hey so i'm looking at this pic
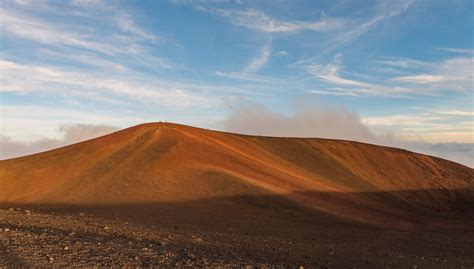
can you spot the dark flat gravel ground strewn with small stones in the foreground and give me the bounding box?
[0,205,474,268]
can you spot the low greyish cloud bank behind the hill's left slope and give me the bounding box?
[0,124,119,160]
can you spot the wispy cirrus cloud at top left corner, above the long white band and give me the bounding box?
[0,1,170,68]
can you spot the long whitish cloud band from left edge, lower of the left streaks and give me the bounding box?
[0,60,216,107]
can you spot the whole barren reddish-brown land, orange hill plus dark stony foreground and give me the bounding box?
[0,123,474,268]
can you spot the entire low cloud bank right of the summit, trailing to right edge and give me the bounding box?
[222,103,474,167]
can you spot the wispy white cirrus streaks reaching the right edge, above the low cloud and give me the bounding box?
[298,51,474,97]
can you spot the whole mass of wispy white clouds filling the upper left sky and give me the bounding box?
[0,1,208,107]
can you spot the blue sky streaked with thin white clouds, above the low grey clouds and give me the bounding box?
[0,0,474,163]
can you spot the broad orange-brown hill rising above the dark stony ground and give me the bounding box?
[0,123,474,227]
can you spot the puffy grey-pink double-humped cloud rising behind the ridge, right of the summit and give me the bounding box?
[223,104,375,141]
